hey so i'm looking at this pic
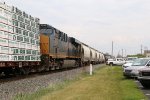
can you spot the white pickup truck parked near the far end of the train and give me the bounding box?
[106,58,125,66]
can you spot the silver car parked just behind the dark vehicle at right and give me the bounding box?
[123,58,150,77]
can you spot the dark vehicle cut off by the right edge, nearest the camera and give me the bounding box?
[138,66,150,88]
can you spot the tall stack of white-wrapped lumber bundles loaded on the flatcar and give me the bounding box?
[0,2,40,61]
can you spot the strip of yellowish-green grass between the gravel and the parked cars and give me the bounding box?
[16,66,147,100]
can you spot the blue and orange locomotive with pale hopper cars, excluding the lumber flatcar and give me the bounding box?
[40,24,105,69]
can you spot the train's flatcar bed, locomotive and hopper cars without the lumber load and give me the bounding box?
[0,24,105,74]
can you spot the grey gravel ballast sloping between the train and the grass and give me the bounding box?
[0,65,101,100]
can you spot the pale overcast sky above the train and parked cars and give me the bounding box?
[1,0,150,54]
